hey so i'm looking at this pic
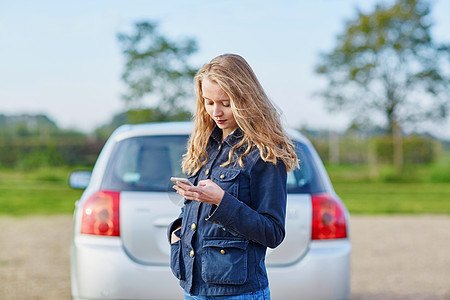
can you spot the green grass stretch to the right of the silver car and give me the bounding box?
[326,161,450,214]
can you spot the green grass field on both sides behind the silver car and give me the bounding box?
[0,166,450,216]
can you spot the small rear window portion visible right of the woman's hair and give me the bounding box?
[287,141,325,194]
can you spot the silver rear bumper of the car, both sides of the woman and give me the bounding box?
[71,235,351,300]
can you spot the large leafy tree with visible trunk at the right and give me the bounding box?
[316,0,450,171]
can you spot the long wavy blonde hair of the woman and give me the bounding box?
[182,54,298,175]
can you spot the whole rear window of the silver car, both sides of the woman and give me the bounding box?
[102,135,325,194]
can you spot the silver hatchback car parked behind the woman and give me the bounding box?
[70,122,352,300]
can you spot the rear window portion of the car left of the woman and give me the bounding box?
[102,135,188,191]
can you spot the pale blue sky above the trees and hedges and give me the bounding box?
[0,0,450,139]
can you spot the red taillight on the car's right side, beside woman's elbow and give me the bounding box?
[311,194,347,240]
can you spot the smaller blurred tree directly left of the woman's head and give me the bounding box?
[117,22,197,119]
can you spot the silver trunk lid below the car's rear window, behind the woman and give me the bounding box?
[120,192,311,266]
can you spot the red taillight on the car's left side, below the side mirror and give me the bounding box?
[81,191,120,236]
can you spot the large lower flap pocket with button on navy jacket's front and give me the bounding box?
[202,237,248,285]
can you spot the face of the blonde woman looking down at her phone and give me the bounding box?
[202,78,238,139]
